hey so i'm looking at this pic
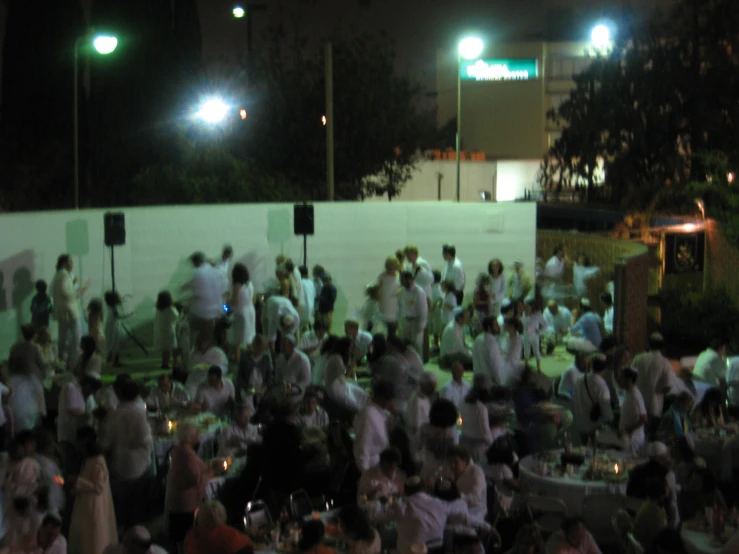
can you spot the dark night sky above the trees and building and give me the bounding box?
[0,0,672,92]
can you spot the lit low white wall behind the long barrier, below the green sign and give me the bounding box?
[368,160,540,202]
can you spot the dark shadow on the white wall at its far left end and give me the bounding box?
[0,250,35,348]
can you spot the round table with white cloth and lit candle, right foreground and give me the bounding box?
[518,450,628,515]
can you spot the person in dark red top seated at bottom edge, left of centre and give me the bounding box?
[184,500,254,554]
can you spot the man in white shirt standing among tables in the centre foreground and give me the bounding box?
[354,381,394,472]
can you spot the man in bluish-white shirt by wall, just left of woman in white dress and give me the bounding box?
[182,252,228,344]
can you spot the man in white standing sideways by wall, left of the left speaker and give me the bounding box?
[51,254,87,367]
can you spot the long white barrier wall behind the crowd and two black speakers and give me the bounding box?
[0,202,536,352]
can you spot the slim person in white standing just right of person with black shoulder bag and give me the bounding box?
[631,333,675,436]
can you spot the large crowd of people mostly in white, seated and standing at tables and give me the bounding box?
[0,245,739,554]
